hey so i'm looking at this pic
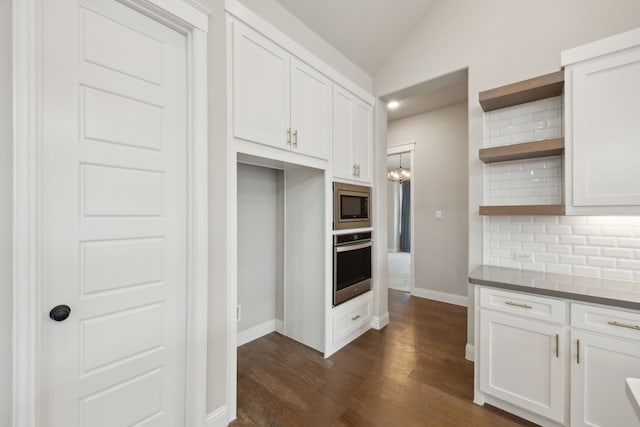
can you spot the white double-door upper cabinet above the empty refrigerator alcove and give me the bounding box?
[233,22,331,159]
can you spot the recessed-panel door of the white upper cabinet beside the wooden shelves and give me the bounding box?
[570,47,640,209]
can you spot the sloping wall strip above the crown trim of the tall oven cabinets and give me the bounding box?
[240,0,373,93]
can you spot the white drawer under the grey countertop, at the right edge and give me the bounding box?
[571,303,640,341]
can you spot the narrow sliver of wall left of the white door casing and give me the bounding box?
[0,0,13,426]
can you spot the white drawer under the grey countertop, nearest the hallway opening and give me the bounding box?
[480,288,567,323]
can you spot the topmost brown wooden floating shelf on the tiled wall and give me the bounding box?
[479,70,564,112]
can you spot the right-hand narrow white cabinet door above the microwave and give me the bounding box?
[353,100,373,182]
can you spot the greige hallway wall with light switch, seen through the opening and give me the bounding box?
[387,102,468,297]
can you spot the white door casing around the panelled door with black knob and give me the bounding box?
[12,0,209,427]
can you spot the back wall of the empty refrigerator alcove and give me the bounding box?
[238,164,282,332]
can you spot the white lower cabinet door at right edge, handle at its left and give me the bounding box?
[571,331,640,427]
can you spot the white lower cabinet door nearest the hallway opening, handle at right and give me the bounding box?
[480,310,566,423]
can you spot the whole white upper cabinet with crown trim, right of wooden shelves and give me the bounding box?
[562,29,640,215]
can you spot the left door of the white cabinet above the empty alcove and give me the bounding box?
[233,22,290,149]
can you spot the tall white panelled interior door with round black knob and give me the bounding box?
[39,0,187,427]
